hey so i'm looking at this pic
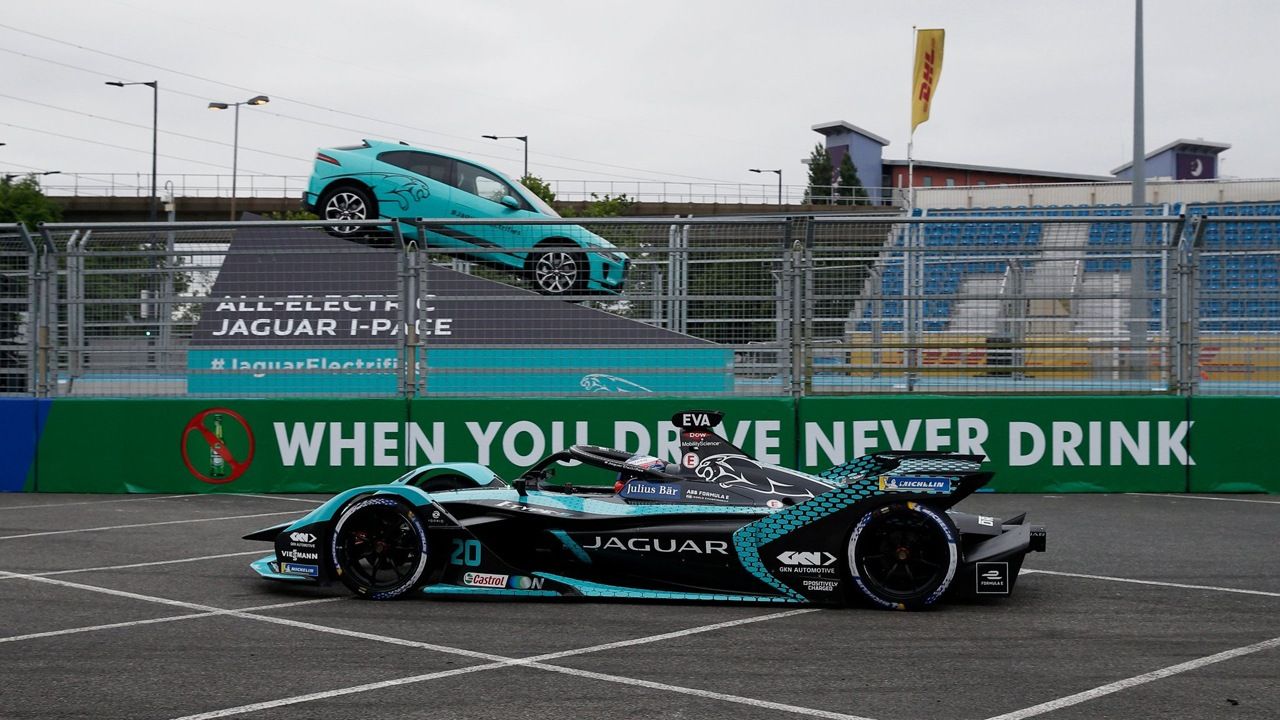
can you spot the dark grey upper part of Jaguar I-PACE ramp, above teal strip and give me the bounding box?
[191,227,714,347]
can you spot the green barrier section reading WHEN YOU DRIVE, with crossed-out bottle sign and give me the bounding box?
[27,397,796,492]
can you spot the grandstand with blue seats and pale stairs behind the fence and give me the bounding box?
[845,181,1280,392]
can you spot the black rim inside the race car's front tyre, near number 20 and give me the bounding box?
[338,506,422,592]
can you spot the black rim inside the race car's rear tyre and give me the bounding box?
[858,511,950,601]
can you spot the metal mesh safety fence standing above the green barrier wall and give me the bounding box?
[0,205,1280,397]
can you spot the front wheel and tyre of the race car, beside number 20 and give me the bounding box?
[332,496,428,600]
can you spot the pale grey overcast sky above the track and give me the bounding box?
[0,0,1280,194]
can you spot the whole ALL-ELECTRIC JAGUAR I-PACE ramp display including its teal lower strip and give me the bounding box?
[187,227,733,395]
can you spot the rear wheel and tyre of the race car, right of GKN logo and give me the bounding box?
[847,502,960,610]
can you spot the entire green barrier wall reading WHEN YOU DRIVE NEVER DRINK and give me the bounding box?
[22,396,1280,493]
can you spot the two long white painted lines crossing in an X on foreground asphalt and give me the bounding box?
[0,571,868,720]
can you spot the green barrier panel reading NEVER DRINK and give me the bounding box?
[799,396,1192,492]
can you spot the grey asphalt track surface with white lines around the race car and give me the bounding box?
[0,495,1280,720]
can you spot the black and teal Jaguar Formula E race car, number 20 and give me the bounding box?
[244,411,1046,610]
